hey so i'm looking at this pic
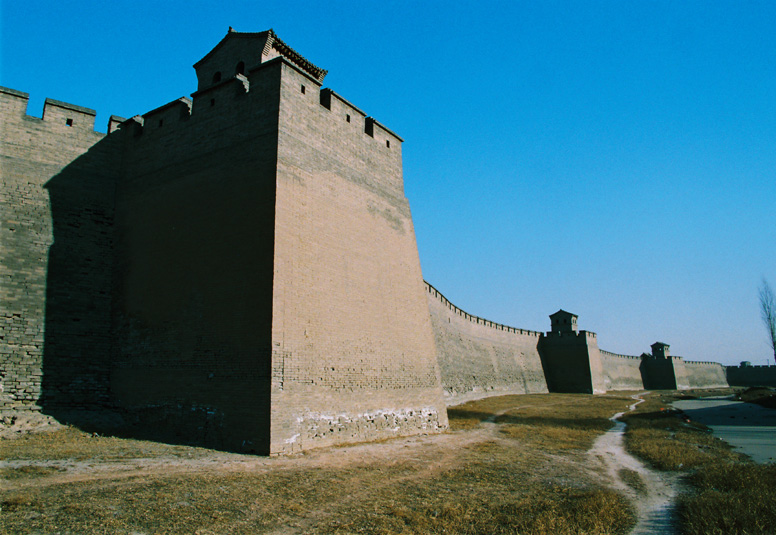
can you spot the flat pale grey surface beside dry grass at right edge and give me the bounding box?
[673,398,776,463]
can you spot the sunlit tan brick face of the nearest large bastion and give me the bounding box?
[271,60,447,452]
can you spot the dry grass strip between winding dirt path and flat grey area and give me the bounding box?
[623,391,776,535]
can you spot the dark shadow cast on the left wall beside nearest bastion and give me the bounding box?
[40,138,115,424]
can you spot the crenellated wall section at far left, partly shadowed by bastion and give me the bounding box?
[0,88,117,413]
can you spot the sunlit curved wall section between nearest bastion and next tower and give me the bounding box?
[425,283,548,405]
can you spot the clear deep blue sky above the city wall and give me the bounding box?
[0,0,776,364]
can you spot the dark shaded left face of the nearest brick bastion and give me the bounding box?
[109,62,280,453]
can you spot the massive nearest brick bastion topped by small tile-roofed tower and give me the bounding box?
[111,28,447,454]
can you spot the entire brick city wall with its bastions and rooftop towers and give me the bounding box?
[0,30,725,454]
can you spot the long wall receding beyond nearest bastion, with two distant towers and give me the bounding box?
[426,282,727,398]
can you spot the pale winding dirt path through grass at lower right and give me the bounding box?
[588,394,677,535]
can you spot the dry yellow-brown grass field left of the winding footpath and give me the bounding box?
[0,394,640,535]
